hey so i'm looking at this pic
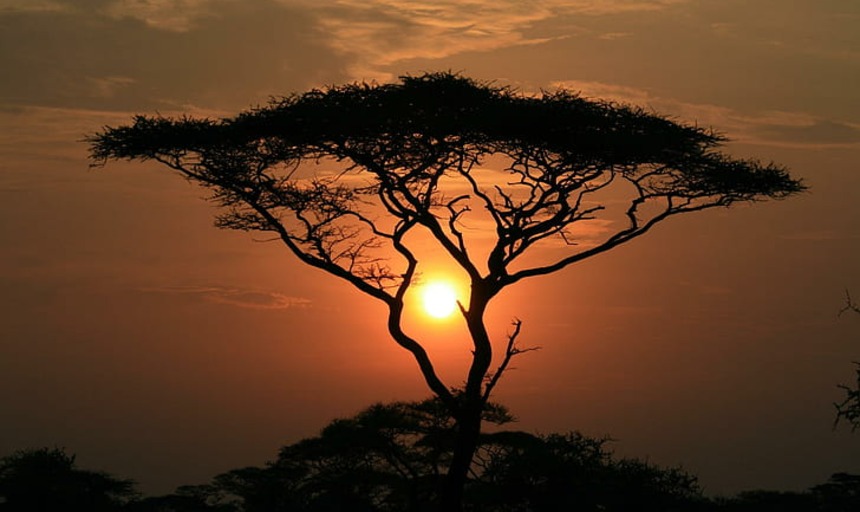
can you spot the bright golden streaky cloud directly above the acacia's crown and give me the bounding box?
[306,0,687,80]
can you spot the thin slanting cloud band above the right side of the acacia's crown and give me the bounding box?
[552,80,860,148]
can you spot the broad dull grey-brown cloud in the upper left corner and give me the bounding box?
[0,0,345,112]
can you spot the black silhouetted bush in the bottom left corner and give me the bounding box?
[0,448,136,512]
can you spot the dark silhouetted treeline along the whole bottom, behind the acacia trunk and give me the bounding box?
[0,400,860,512]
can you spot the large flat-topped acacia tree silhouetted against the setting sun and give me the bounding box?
[88,73,804,510]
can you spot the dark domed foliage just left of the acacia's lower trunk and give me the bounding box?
[195,400,512,512]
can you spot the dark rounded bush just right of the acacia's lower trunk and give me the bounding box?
[472,432,704,512]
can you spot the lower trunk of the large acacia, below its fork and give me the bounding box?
[439,397,483,512]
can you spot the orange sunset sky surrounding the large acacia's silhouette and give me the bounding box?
[0,0,860,493]
